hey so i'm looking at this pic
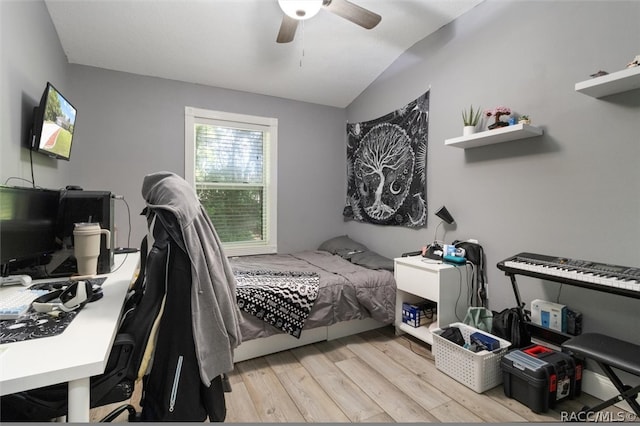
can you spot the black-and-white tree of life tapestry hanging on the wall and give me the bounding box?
[343,91,429,227]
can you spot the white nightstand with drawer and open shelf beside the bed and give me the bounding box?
[394,256,471,345]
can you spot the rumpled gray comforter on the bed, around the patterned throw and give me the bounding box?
[229,251,396,341]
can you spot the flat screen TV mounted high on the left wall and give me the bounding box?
[31,83,77,161]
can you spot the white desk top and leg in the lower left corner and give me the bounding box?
[0,253,140,422]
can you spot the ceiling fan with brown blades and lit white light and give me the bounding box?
[276,0,382,43]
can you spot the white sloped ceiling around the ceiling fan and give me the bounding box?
[45,0,482,107]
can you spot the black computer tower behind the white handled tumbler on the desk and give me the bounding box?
[52,190,115,275]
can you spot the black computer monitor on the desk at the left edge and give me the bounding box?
[0,185,60,276]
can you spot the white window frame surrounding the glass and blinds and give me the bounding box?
[184,106,278,256]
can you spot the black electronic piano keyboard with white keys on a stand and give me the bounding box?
[497,253,640,299]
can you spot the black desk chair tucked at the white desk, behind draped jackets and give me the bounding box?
[0,237,165,422]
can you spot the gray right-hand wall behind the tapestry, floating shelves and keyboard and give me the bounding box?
[346,0,640,343]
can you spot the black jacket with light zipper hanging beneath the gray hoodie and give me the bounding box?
[132,208,231,422]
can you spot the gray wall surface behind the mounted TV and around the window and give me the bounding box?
[0,0,346,252]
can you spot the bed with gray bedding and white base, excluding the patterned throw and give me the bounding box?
[229,235,396,362]
